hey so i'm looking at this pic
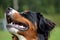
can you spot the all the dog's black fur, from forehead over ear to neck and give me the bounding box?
[21,11,55,40]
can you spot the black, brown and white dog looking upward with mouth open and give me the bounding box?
[6,7,55,40]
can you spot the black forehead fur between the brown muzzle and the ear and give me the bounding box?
[21,11,37,24]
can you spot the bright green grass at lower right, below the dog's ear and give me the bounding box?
[49,27,60,40]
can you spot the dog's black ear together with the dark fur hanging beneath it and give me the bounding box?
[37,13,55,40]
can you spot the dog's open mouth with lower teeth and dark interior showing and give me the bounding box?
[7,20,28,31]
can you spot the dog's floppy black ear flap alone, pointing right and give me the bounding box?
[37,13,55,32]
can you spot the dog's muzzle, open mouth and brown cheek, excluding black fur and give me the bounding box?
[6,8,37,40]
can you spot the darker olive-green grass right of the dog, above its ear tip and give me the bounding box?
[44,14,60,27]
